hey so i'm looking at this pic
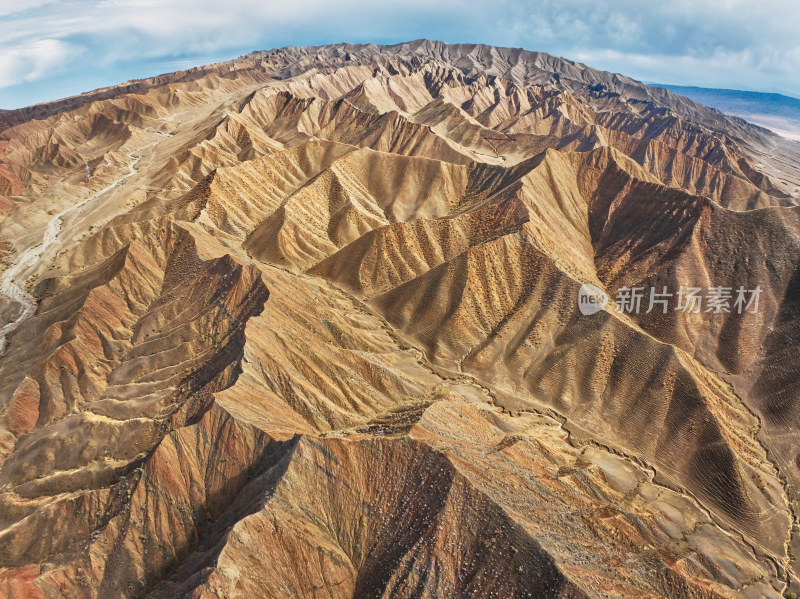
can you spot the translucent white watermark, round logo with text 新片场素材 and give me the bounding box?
[578,283,762,316]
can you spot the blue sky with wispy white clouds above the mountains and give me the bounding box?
[0,0,800,109]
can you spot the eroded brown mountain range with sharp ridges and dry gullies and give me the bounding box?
[0,41,800,599]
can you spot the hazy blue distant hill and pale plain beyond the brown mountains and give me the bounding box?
[656,83,800,141]
